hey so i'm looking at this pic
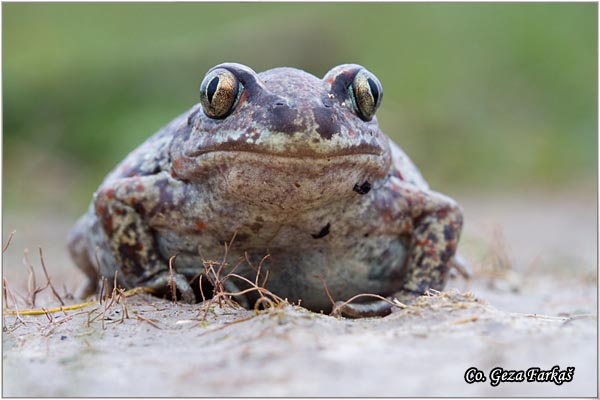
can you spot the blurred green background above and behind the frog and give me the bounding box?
[2,3,598,215]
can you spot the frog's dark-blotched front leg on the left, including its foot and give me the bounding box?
[94,173,195,303]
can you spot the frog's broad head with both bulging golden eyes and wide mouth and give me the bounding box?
[172,63,390,209]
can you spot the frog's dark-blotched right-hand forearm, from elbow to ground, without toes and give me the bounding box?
[396,184,463,302]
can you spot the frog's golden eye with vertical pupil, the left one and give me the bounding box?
[200,68,242,119]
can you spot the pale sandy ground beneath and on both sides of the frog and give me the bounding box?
[2,190,598,396]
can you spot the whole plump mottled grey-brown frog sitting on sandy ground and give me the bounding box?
[68,62,465,317]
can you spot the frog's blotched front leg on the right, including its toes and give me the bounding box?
[337,184,464,318]
